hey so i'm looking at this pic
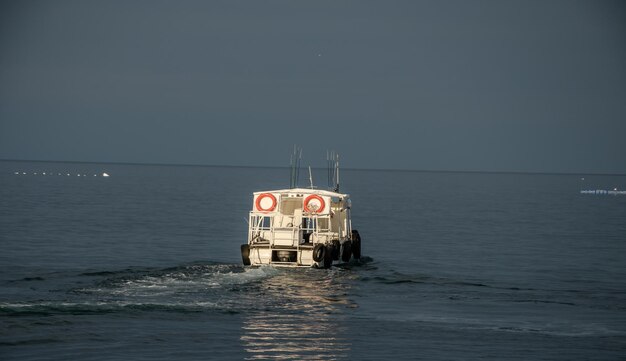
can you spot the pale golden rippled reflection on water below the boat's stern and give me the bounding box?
[241,269,354,360]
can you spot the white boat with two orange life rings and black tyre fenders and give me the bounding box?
[241,150,361,268]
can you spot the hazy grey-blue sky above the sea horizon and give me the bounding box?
[0,0,626,173]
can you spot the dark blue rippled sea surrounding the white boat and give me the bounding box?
[0,162,626,360]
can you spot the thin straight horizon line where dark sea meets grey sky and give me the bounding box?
[0,158,626,176]
